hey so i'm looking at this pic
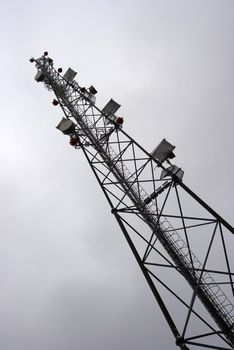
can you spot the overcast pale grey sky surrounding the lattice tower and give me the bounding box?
[0,0,234,350]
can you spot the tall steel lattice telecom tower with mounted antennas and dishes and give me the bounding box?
[30,52,234,349]
